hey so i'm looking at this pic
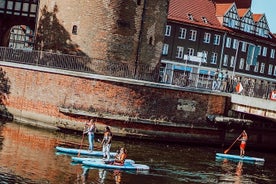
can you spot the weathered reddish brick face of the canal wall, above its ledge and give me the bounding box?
[3,67,227,124]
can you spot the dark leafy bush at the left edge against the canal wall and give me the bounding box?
[0,68,13,121]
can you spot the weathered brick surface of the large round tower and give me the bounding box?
[37,0,168,66]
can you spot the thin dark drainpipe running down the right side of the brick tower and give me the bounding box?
[134,0,147,78]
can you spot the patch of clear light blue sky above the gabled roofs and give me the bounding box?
[251,0,276,33]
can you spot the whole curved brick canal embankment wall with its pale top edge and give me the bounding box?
[2,64,228,132]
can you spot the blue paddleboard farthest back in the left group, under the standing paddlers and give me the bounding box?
[56,146,116,157]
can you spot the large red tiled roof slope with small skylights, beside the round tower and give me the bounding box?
[168,0,222,28]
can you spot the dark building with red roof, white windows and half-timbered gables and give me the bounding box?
[161,0,276,94]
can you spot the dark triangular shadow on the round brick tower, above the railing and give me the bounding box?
[36,5,87,56]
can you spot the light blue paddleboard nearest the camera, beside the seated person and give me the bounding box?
[82,160,150,171]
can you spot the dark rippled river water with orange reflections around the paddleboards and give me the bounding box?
[0,122,276,184]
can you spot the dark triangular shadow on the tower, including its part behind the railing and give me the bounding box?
[35,5,99,72]
